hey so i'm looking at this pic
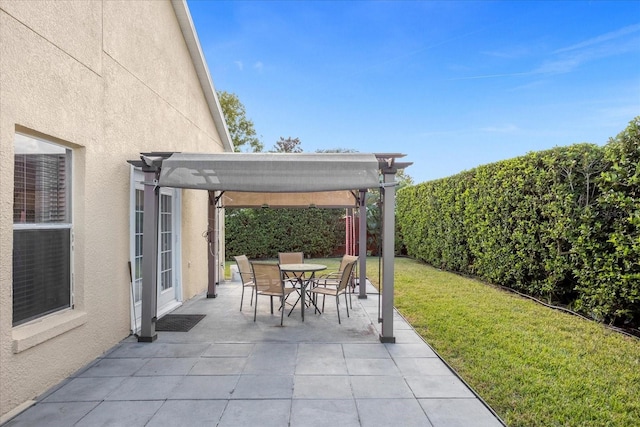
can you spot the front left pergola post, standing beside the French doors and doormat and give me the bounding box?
[138,166,160,342]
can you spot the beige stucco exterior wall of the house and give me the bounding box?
[0,0,223,415]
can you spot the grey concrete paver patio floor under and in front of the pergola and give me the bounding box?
[4,282,503,427]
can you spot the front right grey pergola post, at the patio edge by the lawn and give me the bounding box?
[380,168,396,343]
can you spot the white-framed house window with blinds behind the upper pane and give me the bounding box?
[13,133,72,326]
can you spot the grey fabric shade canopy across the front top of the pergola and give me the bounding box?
[158,153,380,193]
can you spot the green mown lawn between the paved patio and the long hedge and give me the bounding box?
[356,258,640,427]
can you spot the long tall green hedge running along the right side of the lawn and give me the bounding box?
[397,117,640,325]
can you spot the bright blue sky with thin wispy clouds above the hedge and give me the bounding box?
[188,0,640,182]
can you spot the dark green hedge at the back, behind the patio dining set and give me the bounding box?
[225,209,345,259]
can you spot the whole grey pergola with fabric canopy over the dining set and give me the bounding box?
[130,153,412,343]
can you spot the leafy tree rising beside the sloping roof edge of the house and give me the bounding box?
[218,90,264,152]
